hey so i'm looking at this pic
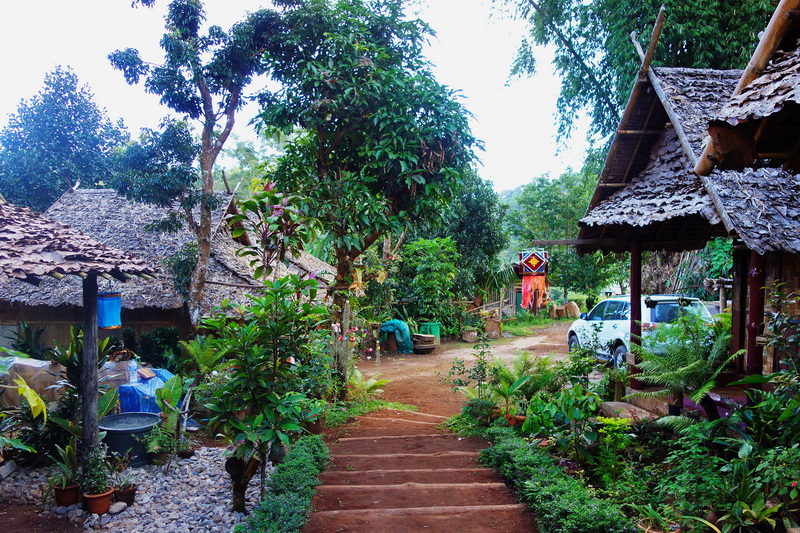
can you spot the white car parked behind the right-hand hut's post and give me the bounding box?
[567,294,712,367]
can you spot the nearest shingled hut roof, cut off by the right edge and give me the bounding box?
[696,0,800,255]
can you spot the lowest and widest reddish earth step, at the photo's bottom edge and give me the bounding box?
[303,504,536,533]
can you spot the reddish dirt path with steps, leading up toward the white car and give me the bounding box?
[303,324,567,533]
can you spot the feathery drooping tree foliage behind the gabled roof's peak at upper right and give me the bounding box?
[505,0,774,134]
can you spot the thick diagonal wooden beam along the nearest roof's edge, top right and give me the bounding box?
[694,0,800,176]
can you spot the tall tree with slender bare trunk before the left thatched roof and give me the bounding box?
[109,0,280,322]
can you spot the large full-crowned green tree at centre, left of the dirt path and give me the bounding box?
[260,0,477,324]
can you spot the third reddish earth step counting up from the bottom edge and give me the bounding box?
[320,468,498,485]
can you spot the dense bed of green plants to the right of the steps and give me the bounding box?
[448,291,800,533]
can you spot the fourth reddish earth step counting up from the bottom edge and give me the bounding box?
[328,451,480,470]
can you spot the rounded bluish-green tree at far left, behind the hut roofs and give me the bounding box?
[0,67,127,211]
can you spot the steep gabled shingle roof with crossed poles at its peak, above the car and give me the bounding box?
[576,68,740,252]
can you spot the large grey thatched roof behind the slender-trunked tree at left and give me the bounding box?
[0,189,332,313]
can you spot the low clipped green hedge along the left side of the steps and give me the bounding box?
[234,435,329,533]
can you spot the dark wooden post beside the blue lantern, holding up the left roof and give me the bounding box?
[81,273,100,450]
